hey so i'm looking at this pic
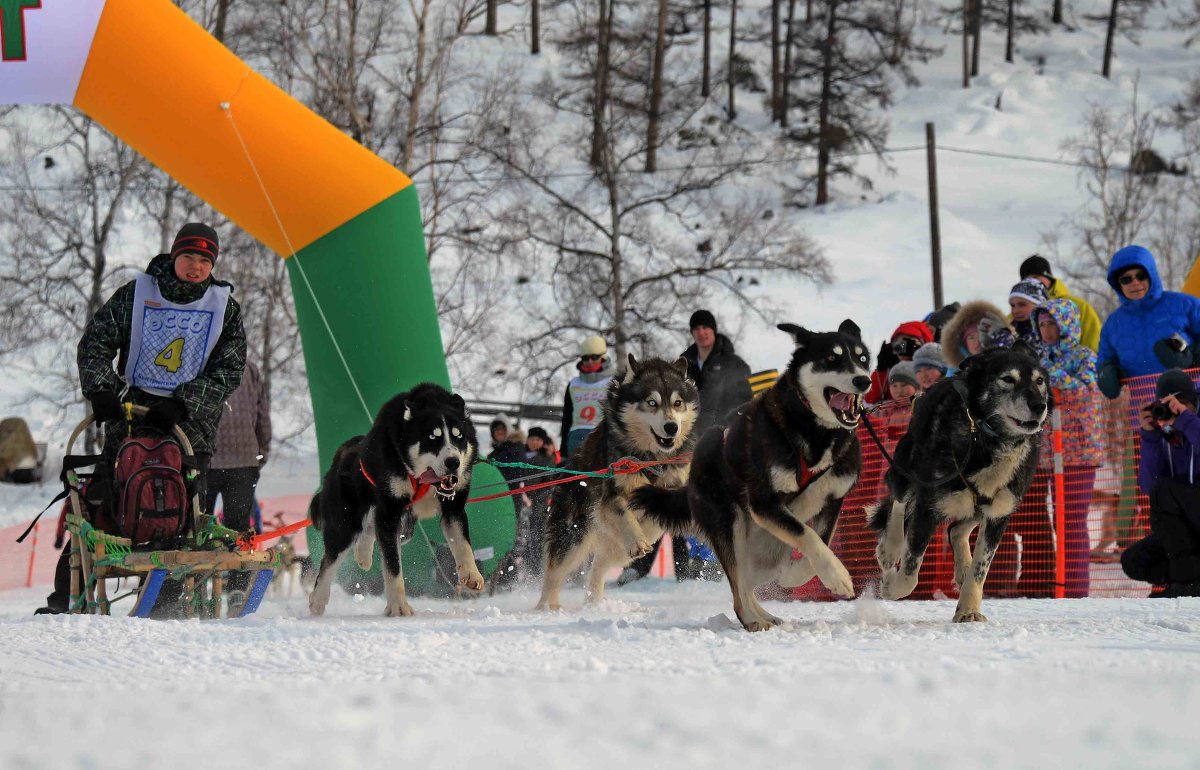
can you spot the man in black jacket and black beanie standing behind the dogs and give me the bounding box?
[683,311,754,440]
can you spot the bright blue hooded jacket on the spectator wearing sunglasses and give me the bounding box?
[1098,246,1200,378]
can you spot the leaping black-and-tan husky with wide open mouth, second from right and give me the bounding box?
[634,320,871,631]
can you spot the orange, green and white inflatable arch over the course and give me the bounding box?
[0,0,512,588]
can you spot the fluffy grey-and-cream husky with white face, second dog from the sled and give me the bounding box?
[538,355,700,609]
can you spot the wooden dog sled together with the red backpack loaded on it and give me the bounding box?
[62,404,277,618]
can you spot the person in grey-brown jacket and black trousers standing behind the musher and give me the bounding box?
[204,359,271,602]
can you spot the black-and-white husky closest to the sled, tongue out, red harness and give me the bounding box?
[308,383,484,615]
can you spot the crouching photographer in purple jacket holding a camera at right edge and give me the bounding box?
[1121,369,1200,597]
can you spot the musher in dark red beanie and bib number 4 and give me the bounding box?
[37,223,246,613]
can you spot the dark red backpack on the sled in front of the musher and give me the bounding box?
[112,437,187,546]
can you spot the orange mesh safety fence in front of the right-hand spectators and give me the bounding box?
[790,372,1180,600]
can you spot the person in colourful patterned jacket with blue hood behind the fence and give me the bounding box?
[1022,299,1104,598]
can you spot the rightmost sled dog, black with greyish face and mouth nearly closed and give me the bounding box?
[870,343,1054,622]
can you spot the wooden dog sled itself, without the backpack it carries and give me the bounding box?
[62,404,277,619]
